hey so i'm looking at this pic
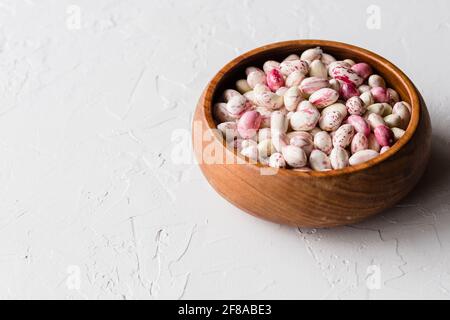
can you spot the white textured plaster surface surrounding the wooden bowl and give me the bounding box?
[0,0,450,299]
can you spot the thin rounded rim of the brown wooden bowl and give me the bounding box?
[200,39,421,177]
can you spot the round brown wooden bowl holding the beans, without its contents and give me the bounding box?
[193,40,431,228]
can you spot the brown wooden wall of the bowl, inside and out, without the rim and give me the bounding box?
[194,41,431,228]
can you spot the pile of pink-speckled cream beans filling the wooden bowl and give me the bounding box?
[213,48,411,171]
